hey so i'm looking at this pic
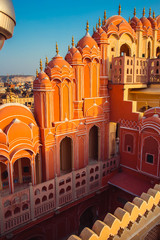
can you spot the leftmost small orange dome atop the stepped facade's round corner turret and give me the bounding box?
[33,71,52,90]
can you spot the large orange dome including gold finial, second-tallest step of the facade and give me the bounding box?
[77,21,100,58]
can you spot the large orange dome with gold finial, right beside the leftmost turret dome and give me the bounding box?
[45,43,73,81]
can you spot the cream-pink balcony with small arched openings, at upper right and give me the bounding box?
[111,53,160,84]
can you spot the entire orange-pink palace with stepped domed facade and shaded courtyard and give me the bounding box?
[0,1,160,240]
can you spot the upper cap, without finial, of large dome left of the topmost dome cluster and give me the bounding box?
[77,33,98,49]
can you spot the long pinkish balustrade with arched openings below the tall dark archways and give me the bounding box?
[0,157,119,235]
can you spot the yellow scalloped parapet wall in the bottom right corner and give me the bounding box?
[68,184,160,240]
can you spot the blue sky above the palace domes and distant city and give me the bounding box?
[0,0,160,75]
